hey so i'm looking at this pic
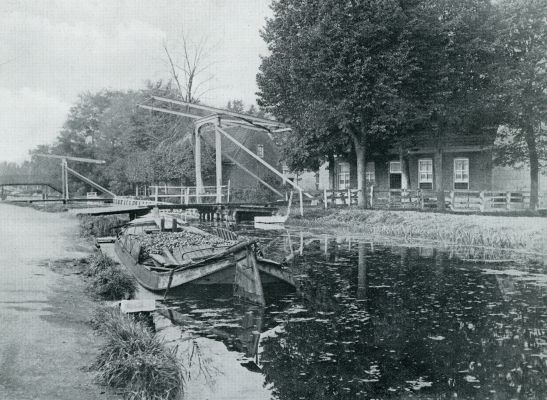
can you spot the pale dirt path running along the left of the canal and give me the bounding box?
[0,205,119,400]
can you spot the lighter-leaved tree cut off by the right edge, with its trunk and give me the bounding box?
[498,0,547,209]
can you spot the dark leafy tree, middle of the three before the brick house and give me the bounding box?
[403,0,500,209]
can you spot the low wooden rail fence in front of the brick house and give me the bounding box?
[312,187,547,212]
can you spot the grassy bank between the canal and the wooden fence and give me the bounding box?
[289,209,547,254]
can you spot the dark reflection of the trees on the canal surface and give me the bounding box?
[260,241,547,400]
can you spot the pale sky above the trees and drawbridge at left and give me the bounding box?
[0,0,271,162]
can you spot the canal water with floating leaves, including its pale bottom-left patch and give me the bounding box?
[155,228,547,400]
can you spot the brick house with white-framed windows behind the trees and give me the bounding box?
[294,136,547,197]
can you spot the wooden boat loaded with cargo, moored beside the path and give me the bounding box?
[105,212,294,296]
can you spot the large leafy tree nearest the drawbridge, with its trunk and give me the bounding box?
[257,0,410,207]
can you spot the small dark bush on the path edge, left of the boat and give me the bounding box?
[91,265,137,300]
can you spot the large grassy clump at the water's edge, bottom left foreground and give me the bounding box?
[92,307,184,400]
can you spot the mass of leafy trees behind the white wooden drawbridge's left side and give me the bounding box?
[24,82,214,194]
